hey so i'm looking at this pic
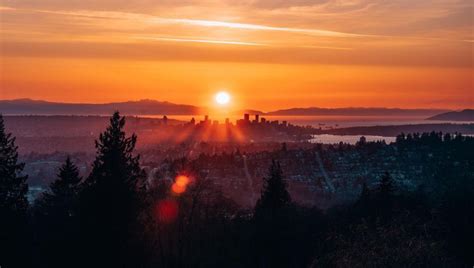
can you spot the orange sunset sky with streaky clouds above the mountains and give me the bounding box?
[0,0,474,111]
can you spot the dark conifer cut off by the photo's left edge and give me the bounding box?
[0,115,28,266]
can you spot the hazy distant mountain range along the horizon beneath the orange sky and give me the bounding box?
[0,99,458,116]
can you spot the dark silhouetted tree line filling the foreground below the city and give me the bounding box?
[0,112,474,267]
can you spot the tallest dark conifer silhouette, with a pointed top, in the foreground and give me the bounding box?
[80,112,146,266]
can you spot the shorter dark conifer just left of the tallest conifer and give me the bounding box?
[35,157,81,267]
